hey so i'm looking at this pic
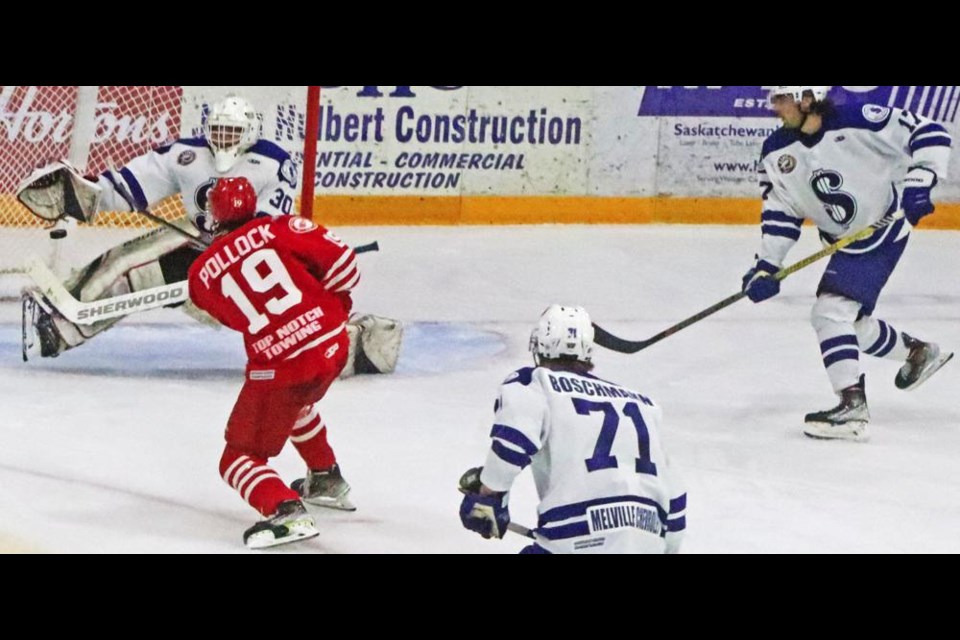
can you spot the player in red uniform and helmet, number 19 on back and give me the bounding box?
[189,178,360,549]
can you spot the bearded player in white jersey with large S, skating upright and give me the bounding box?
[743,86,953,440]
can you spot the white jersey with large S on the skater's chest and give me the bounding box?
[758,104,951,266]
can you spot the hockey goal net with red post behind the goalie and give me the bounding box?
[0,86,306,300]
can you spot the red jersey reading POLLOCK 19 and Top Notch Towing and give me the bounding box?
[189,216,360,366]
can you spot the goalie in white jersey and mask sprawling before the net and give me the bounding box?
[20,96,402,375]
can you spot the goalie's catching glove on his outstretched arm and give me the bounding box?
[17,161,102,222]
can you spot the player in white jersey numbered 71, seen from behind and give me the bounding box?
[460,305,687,554]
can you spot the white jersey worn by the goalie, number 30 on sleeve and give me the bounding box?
[97,138,297,231]
